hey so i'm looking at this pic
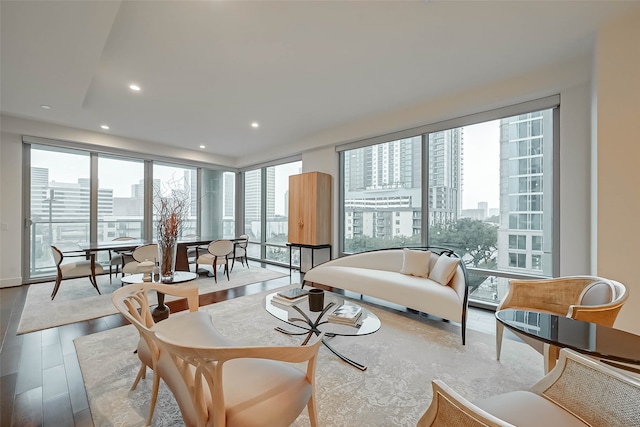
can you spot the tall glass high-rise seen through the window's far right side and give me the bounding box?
[498,110,553,276]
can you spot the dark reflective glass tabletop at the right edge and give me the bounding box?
[496,309,640,364]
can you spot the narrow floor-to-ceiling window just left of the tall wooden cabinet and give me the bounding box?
[243,161,302,264]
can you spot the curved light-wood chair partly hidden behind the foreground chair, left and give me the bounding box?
[111,282,216,425]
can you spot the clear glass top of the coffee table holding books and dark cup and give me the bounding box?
[265,291,381,336]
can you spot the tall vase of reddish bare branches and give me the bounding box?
[154,180,190,283]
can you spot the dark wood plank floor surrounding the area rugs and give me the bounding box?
[0,265,495,427]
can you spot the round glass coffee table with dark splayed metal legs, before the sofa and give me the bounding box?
[265,291,381,371]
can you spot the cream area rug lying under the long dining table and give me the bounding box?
[18,266,289,334]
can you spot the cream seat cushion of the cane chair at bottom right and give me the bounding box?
[474,391,587,427]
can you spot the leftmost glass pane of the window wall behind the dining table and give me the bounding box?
[28,145,91,278]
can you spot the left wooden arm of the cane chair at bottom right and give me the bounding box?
[417,380,515,427]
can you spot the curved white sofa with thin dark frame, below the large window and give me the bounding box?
[302,247,468,345]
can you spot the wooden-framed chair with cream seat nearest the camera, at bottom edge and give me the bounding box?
[156,328,323,427]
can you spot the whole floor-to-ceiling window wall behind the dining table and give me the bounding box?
[23,137,237,281]
